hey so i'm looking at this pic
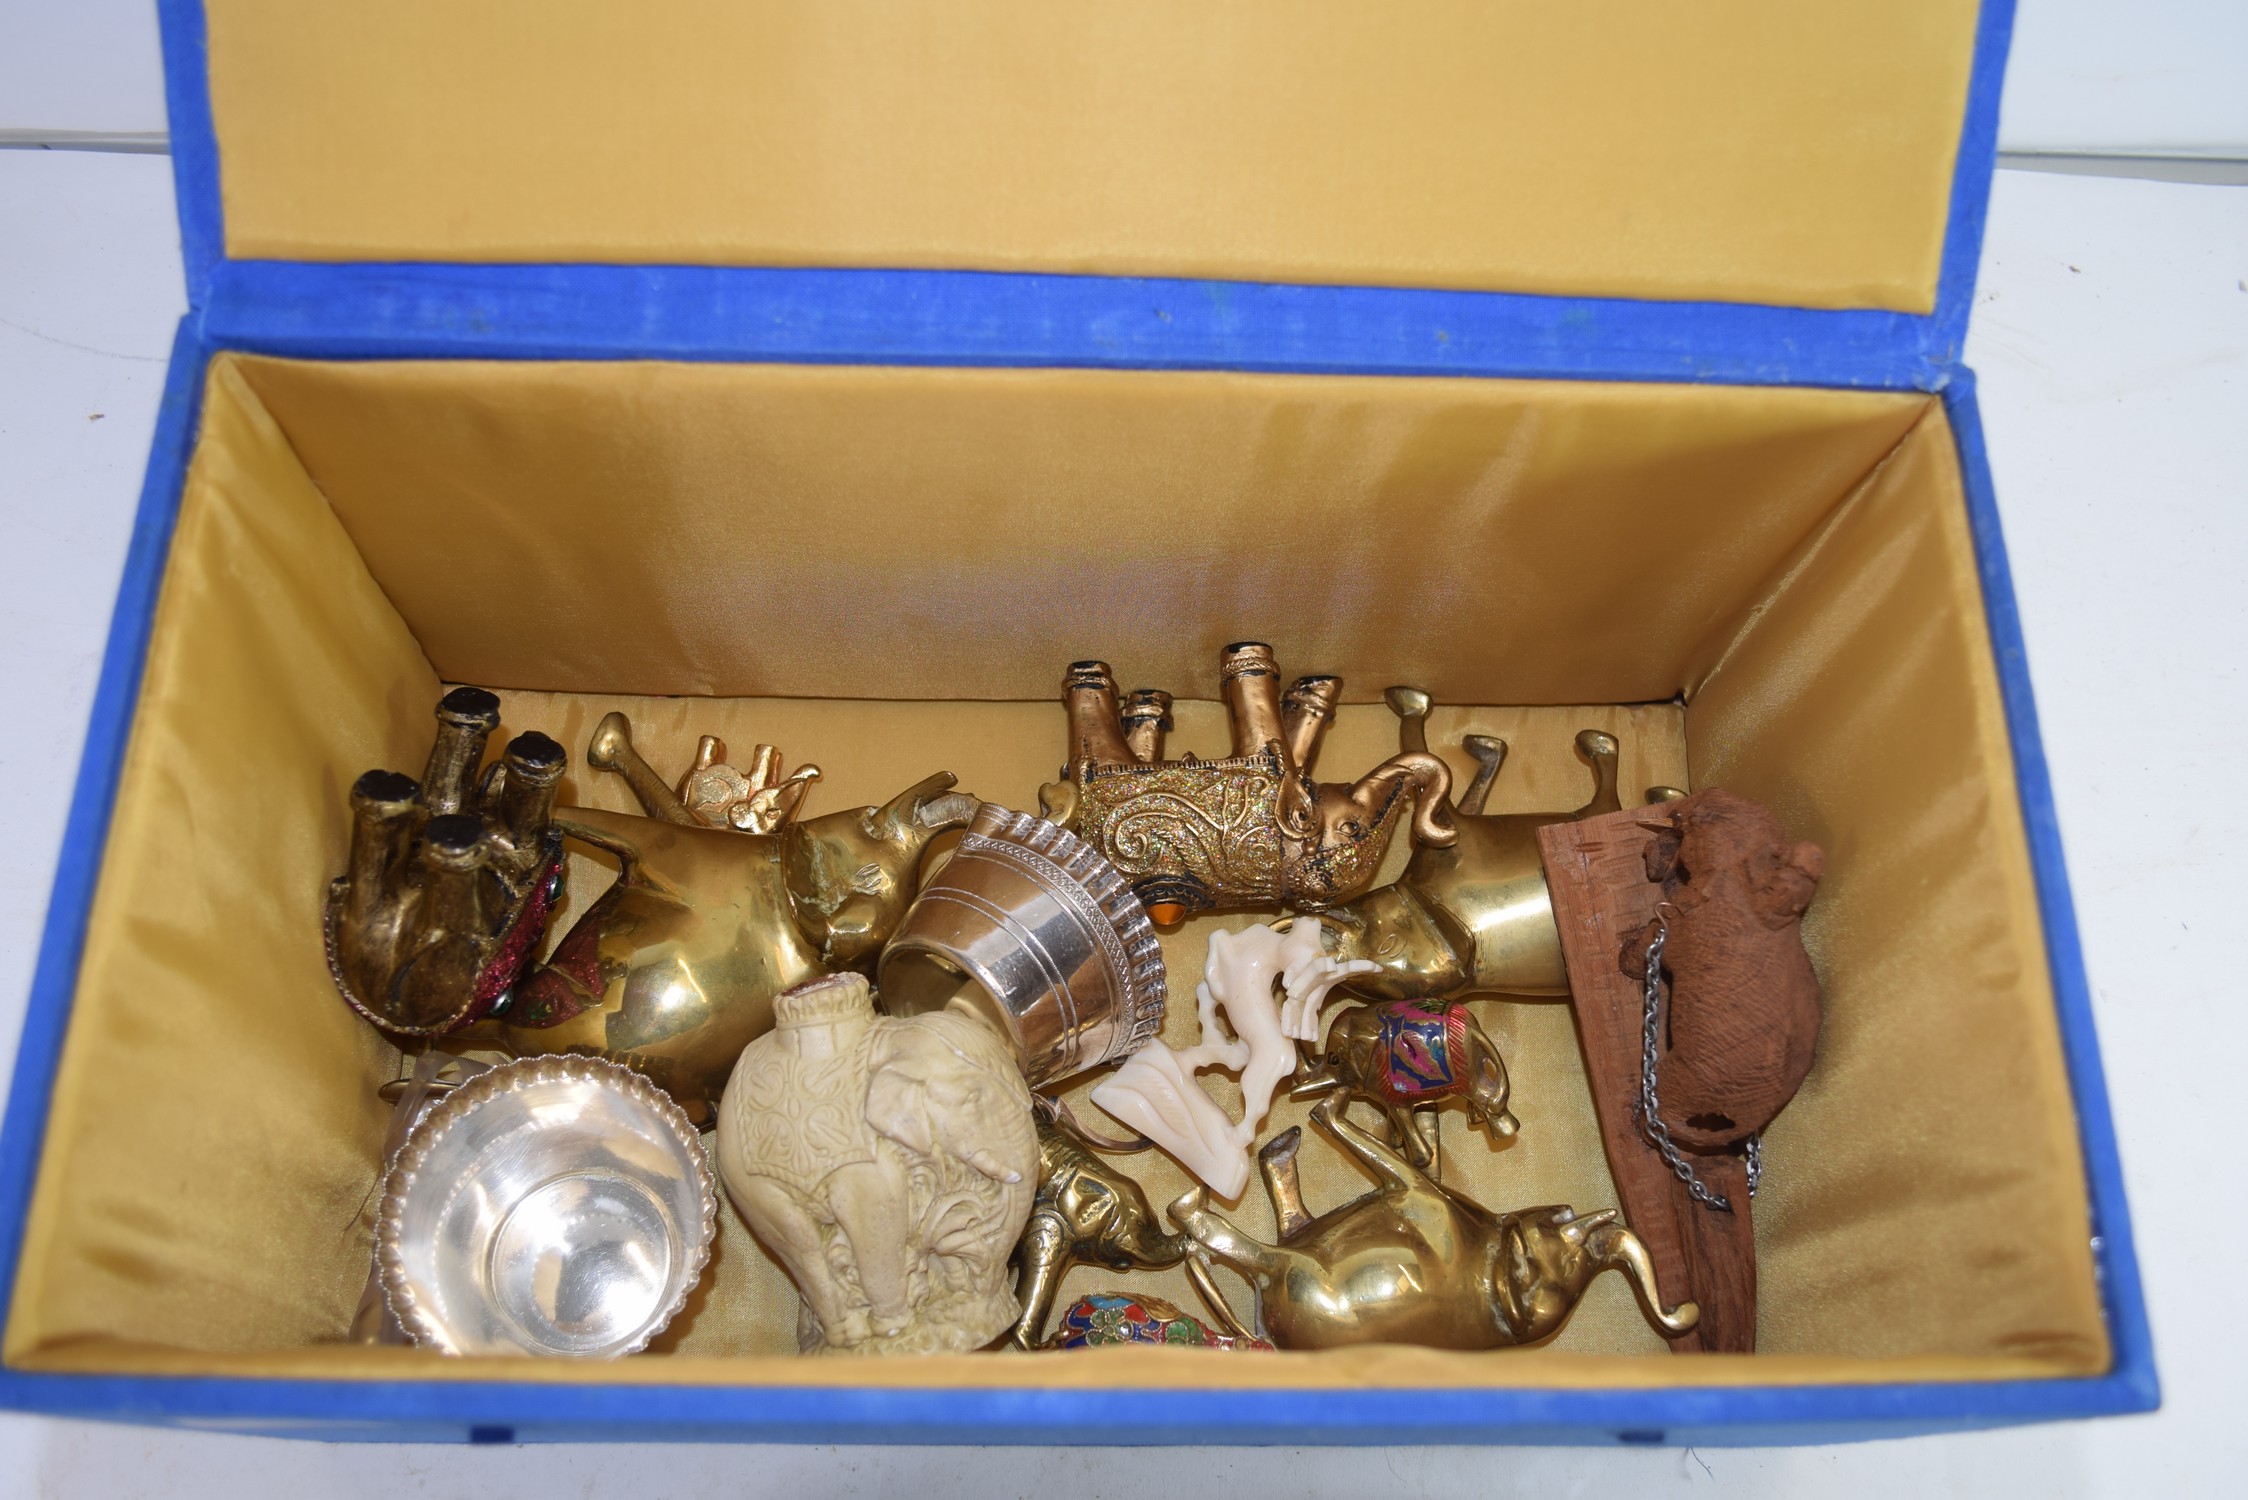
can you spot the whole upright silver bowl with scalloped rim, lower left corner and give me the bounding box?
[375,1057,717,1358]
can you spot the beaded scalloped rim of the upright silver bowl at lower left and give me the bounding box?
[375,1055,717,1358]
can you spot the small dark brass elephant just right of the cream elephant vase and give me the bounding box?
[1009,1095,1189,1349]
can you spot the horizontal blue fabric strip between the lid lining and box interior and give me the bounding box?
[202,261,1942,389]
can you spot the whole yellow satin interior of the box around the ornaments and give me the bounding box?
[4,355,2109,1388]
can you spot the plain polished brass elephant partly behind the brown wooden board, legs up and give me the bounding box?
[1324,688,1682,1001]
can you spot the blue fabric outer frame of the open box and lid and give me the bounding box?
[0,0,2158,1444]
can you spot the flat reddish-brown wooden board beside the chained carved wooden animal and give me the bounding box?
[1538,807,1756,1354]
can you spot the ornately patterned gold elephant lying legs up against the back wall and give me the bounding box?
[1048,641,1454,927]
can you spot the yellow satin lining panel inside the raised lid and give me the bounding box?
[207,0,1978,313]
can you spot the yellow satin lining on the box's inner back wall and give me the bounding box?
[219,360,1927,704]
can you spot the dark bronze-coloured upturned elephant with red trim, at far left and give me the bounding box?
[324,688,569,1037]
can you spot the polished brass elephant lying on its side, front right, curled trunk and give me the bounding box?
[1169,1097,1702,1349]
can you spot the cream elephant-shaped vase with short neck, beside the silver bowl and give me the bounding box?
[717,974,1039,1354]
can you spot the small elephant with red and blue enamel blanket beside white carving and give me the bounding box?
[1288,1001,1522,1169]
